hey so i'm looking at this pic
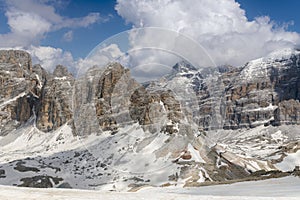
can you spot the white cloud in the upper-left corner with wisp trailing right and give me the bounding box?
[0,0,106,47]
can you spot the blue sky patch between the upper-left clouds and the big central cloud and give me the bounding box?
[38,0,131,58]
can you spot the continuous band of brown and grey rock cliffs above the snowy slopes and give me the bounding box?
[0,51,300,135]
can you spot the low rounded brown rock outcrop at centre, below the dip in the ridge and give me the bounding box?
[129,86,183,134]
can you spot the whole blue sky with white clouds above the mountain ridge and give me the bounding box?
[0,0,300,73]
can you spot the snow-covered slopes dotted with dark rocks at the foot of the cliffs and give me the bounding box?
[0,124,300,191]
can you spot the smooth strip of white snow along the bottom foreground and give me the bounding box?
[0,177,300,200]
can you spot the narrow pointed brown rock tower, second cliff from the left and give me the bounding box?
[36,65,74,131]
